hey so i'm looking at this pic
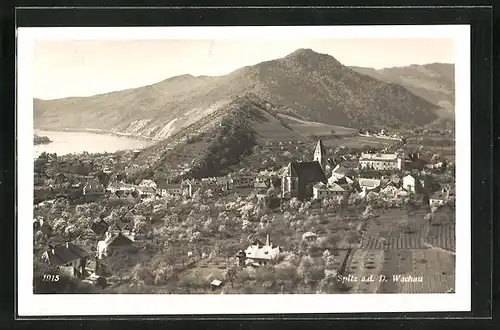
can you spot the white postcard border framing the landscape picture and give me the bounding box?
[16,25,471,316]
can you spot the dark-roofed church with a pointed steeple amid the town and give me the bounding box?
[281,140,327,199]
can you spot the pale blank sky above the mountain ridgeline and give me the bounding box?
[33,38,454,99]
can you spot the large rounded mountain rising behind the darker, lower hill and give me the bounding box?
[34,49,442,140]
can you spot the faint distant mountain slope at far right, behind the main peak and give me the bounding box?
[351,63,455,118]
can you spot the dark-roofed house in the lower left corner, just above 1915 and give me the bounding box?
[42,242,90,278]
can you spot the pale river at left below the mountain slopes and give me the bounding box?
[34,130,154,157]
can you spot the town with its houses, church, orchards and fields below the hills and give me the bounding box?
[33,135,455,294]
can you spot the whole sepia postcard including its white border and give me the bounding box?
[17,26,471,314]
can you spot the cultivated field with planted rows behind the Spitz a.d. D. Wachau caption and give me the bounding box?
[345,209,455,293]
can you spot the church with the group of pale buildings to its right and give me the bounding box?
[281,140,454,205]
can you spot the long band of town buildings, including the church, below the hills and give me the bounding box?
[34,140,448,208]
